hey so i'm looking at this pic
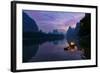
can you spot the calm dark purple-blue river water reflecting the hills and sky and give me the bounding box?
[23,39,84,62]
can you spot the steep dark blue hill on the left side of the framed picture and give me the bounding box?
[23,12,39,32]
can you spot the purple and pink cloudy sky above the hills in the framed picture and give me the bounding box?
[24,10,85,32]
